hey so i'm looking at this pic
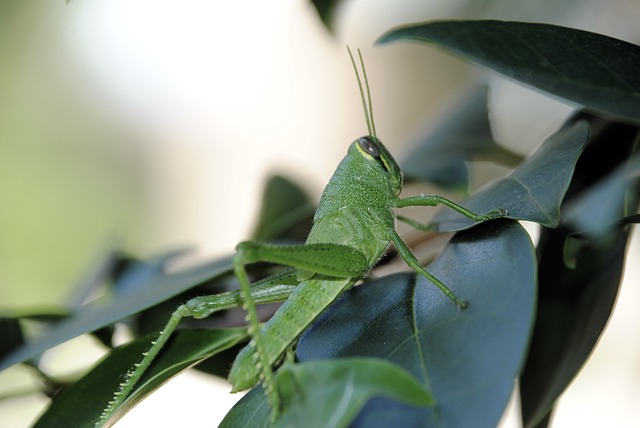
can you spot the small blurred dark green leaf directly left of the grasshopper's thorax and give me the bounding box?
[252,175,315,242]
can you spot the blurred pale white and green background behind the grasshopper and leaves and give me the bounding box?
[0,0,640,427]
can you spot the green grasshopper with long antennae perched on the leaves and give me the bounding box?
[97,48,506,426]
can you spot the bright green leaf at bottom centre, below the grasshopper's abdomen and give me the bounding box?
[275,358,433,428]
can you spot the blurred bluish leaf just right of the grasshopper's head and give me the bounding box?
[400,86,522,193]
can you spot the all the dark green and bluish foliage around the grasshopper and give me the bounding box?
[0,13,640,427]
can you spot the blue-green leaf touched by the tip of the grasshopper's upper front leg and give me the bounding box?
[433,120,589,232]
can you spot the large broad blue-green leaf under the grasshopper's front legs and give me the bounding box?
[297,220,536,427]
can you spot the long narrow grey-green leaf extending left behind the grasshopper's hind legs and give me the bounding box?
[0,260,230,370]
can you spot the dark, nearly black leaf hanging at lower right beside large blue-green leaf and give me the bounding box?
[520,228,628,427]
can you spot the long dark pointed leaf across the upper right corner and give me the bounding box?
[378,21,640,123]
